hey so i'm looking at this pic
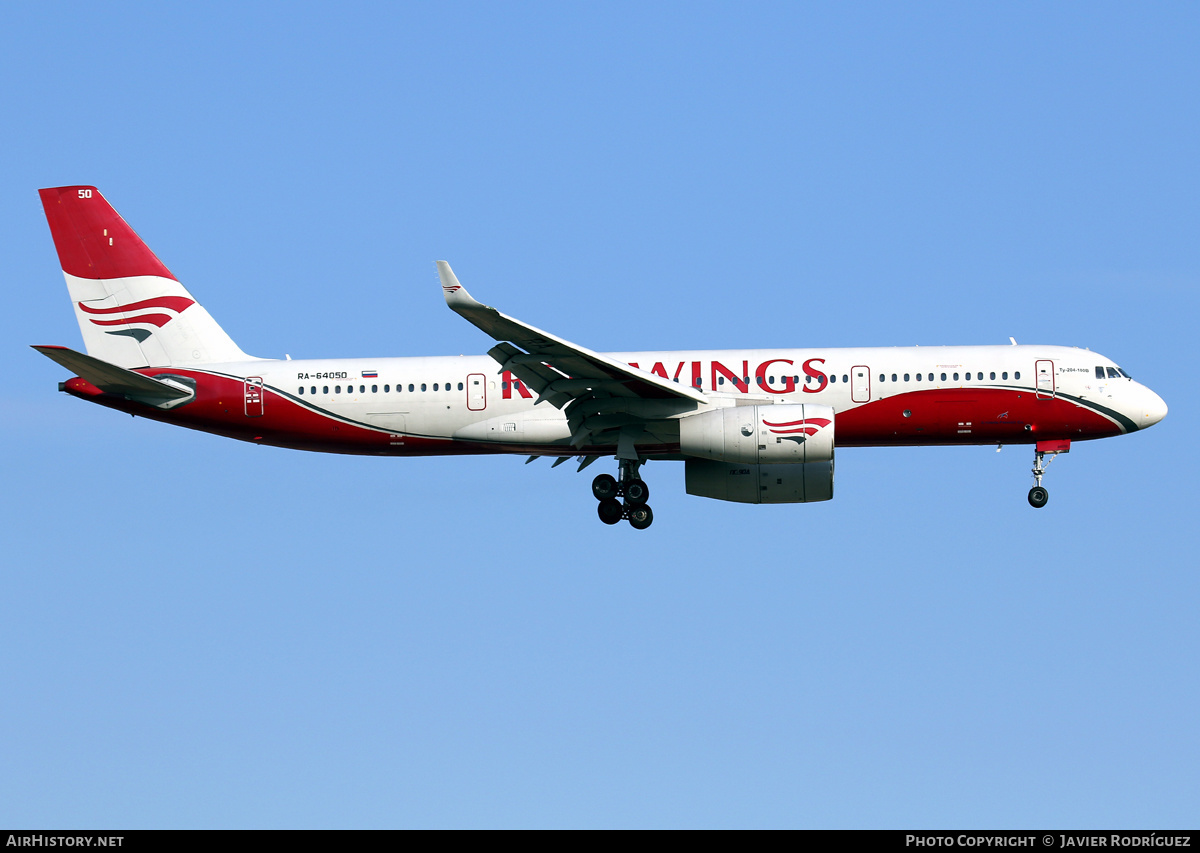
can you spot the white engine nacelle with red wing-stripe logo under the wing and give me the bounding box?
[679,403,834,504]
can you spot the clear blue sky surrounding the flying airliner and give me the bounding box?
[0,2,1200,828]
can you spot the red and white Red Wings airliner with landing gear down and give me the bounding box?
[34,186,1166,529]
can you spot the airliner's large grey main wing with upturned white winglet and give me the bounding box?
[438,260,708,409]
